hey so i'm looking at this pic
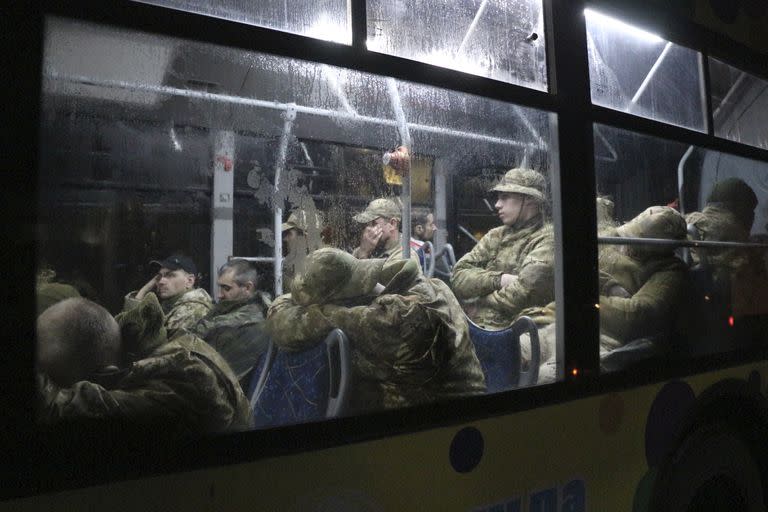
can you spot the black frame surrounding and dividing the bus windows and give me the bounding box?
[6,0,768,499]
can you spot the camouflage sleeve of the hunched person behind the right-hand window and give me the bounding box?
[600,270,685,343]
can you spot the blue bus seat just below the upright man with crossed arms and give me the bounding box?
[467,316,541,393]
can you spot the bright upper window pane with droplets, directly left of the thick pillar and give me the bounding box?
[367,0,547,90]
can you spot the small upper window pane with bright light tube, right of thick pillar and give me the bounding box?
[585,9,706,131]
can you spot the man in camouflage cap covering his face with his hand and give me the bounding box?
[352,197,419,263]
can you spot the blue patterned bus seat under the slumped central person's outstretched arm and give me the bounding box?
[253,329,351,428]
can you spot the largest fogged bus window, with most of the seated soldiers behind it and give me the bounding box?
[38,18,556,433]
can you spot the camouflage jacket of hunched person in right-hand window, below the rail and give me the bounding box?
[600,251,687,343]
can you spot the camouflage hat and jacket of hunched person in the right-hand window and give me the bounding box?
[599,206,686,349]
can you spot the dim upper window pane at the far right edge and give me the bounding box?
[709,58,768,148]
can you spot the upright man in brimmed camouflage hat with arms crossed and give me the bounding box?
[451,168,555,330]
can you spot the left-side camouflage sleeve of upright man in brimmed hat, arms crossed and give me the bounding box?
[451,231,502,299]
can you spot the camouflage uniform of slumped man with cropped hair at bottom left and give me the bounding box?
[40,293,252,435]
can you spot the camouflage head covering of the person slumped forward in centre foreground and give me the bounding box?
[291,248,386,306]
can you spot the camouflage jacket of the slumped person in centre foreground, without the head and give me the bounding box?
[267,260,485,412]
